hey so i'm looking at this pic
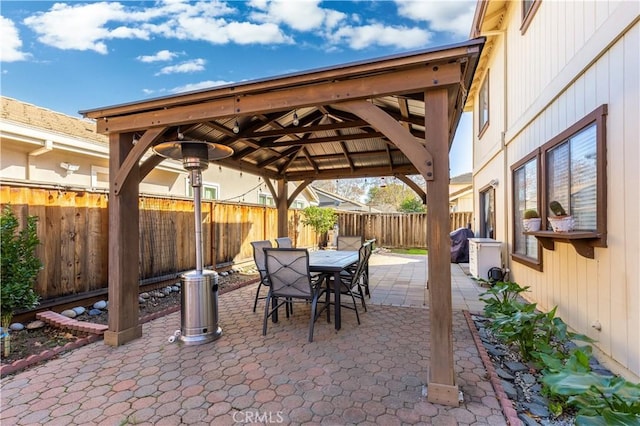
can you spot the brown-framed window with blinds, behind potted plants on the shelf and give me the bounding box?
[543,105,606,233]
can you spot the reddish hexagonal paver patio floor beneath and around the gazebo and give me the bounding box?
[0,255,506,426]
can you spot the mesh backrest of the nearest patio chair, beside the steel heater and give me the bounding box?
[264,248,313,299]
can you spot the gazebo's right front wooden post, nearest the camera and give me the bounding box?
[425,88,459,406]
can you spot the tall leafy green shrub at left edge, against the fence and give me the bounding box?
[0,205,42,356]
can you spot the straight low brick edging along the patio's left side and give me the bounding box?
[0,278,260,378]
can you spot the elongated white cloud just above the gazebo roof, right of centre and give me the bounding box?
[329,24,432,49]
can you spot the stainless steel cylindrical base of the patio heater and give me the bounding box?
[179,270,222,345]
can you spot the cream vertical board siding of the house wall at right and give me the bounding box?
[492,1,640,377]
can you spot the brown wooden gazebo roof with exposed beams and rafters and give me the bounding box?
[80,38,484,185]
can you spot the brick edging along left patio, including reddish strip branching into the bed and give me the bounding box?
[0,278,259,377]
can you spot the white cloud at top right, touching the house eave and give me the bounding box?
[395,0,477,38]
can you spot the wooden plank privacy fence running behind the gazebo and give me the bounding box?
[0,185,471,300]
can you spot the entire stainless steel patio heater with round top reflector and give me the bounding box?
[153,138,233,345]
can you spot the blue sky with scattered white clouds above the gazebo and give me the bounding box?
[0,0,476,175]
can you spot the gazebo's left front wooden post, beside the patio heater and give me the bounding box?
[104,133,142,346]
